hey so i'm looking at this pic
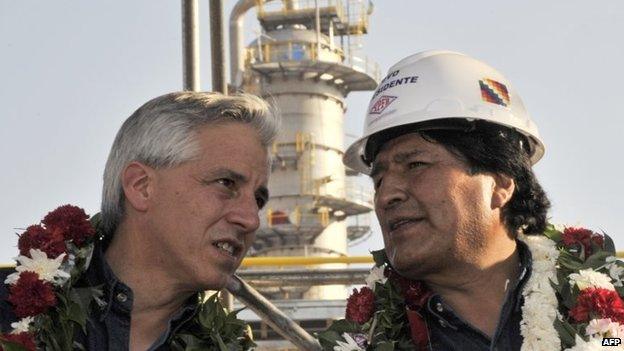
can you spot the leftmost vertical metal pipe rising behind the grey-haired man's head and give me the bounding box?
[182,0,199,91]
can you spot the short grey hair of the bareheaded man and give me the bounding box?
[101,91,279,236]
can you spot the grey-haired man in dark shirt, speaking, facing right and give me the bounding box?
[0,92,278,350]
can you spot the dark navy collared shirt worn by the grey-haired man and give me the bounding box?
[0,245,199,351]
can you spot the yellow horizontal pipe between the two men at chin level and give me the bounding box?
[241,256,374,267]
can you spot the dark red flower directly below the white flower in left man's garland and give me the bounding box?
[8,272,56,318]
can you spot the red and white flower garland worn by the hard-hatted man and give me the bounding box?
[318,225,624,351]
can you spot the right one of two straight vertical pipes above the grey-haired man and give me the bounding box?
[210,0,227,94]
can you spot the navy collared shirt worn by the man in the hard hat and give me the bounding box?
[422,241,532,351]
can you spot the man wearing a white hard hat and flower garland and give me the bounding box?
[319,51,620,350]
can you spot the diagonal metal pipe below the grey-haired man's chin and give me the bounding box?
[227,275,322,351]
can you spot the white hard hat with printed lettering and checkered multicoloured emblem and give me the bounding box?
[343,51,544,174]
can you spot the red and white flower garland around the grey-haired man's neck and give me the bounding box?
[0,205,255,351]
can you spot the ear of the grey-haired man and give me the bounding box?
[121,161,154,212]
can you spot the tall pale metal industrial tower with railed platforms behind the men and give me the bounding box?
[230,0,379,346]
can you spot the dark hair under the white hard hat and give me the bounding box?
[366,120,550,234]
